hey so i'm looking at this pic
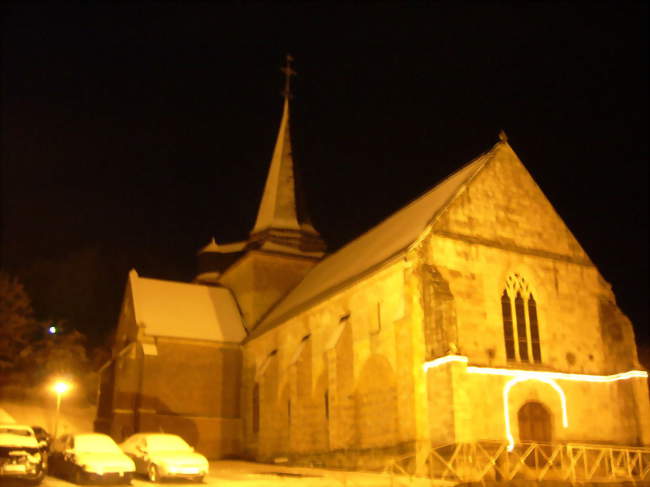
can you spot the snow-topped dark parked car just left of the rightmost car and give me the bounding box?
[49,433,135,484]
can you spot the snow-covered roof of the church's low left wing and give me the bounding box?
[129,271,246,343]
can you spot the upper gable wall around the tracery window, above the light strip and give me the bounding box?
[424,151,638,374]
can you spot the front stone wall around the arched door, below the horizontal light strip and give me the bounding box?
[427,362,647,445]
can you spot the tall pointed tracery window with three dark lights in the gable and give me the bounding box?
[501,274,542,363]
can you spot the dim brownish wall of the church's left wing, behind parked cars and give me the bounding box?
[96,338,242,458]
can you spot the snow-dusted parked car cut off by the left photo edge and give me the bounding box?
[0,424,45,485]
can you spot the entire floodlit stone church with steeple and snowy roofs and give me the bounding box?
[95,60,650,480]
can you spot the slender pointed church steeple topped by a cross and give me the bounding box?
[250,55,325,255]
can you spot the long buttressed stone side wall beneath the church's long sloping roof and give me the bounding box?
[242,263,415,463]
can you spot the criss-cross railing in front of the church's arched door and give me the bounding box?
[385,441,650,485]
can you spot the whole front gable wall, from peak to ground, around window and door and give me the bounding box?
[413,152,650,444]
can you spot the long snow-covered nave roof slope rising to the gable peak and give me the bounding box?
[251,143,502,337]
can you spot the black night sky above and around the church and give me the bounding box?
[1,2,650,341]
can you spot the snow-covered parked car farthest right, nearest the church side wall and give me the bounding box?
[120,433,209,482]
